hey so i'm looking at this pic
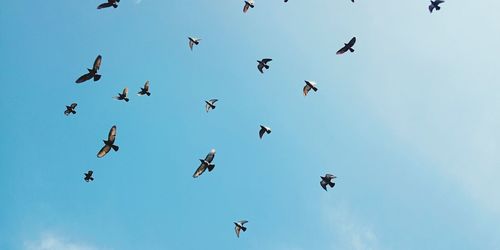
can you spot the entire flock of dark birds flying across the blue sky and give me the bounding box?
[64,0,444,237]
